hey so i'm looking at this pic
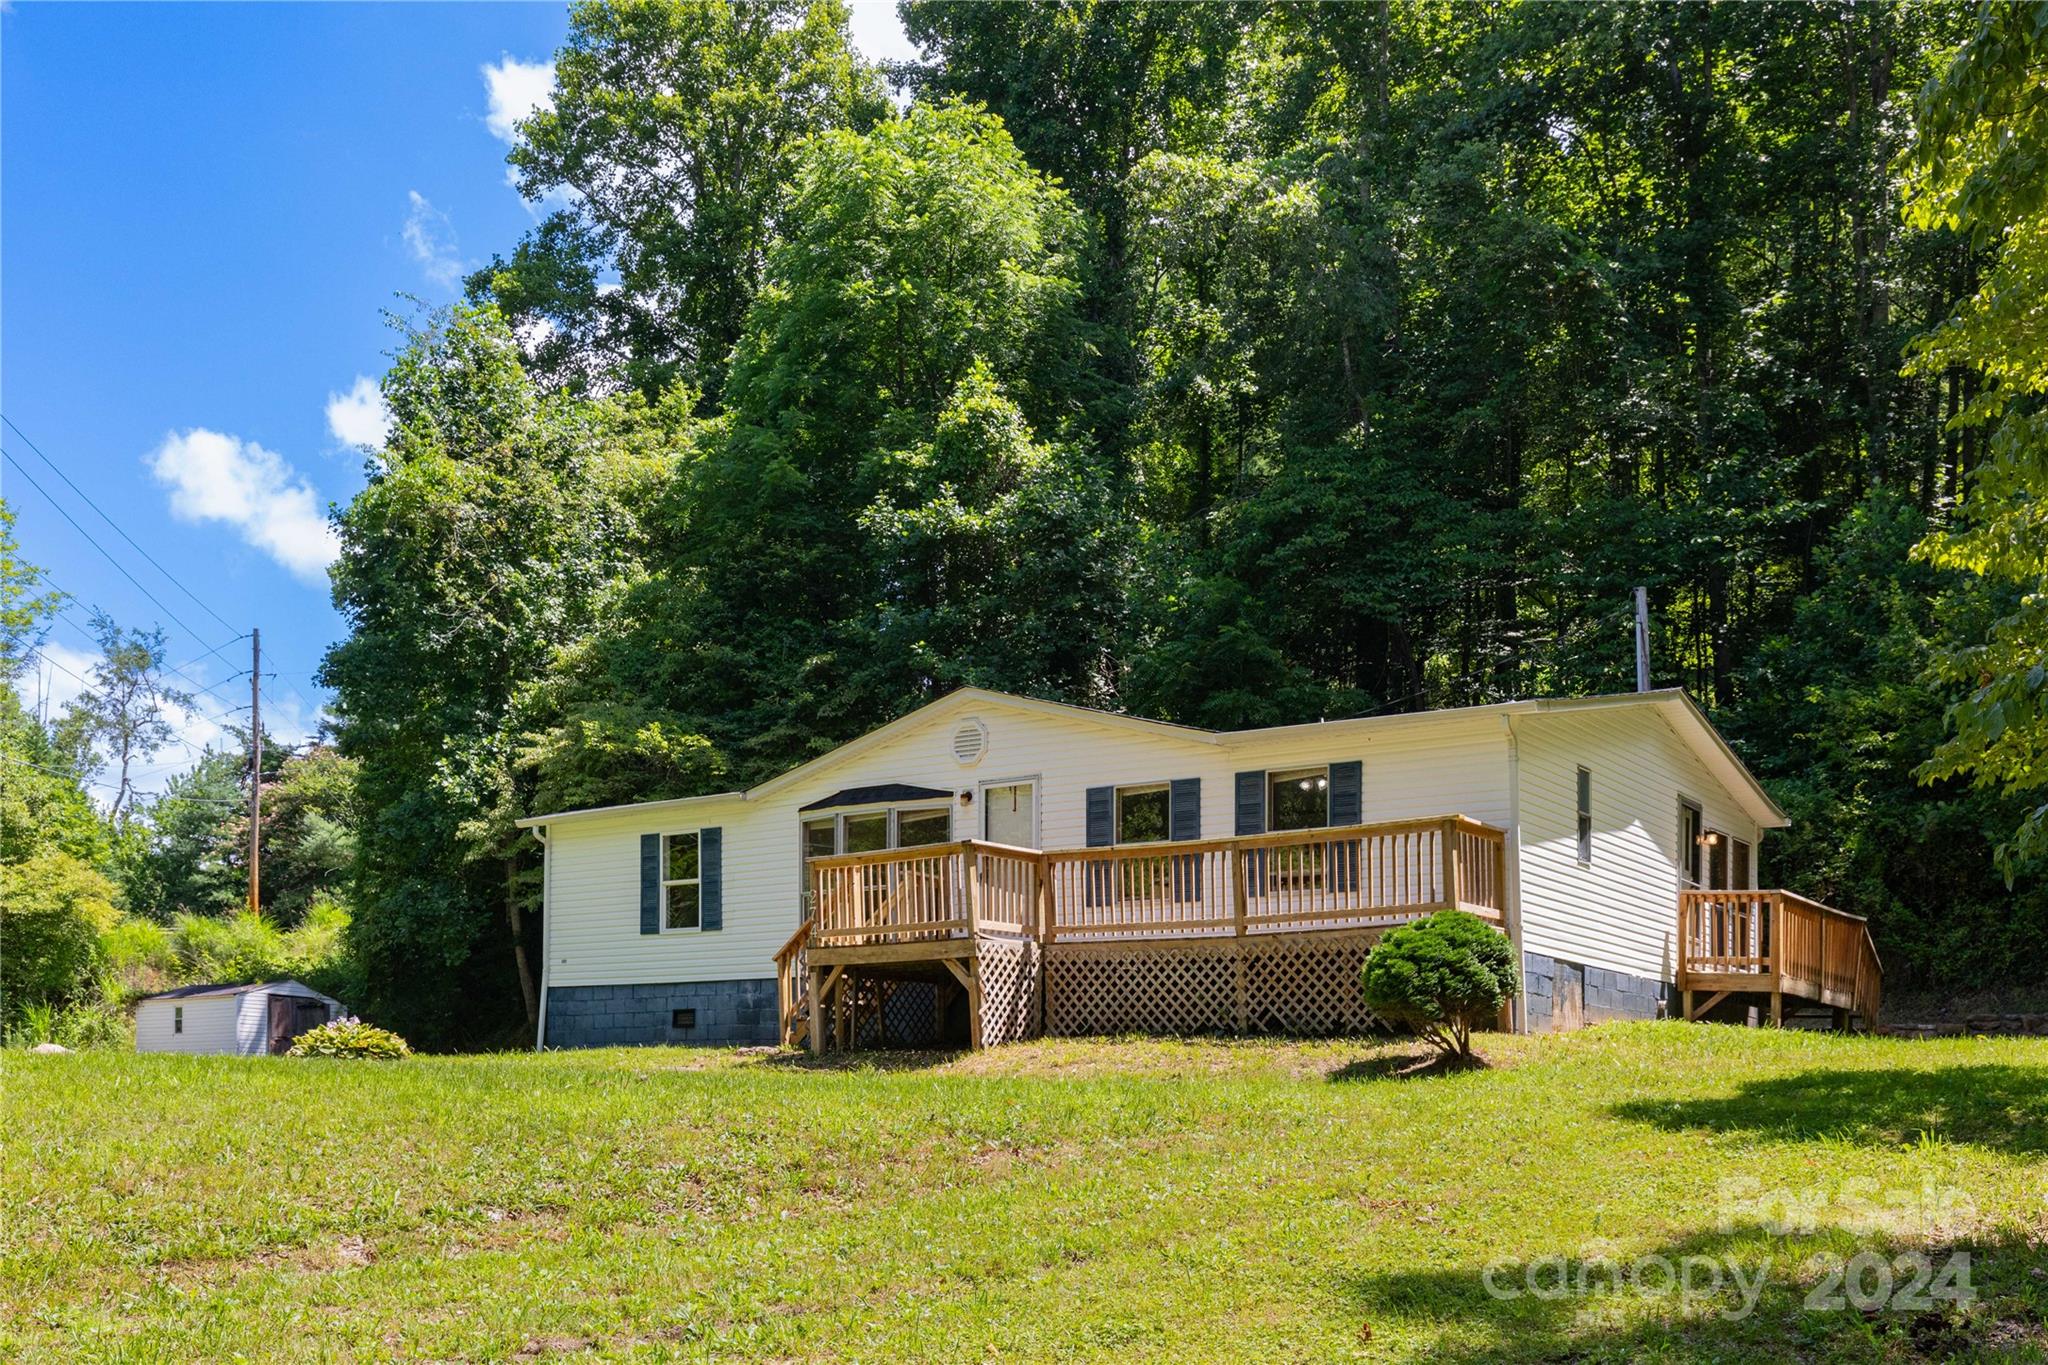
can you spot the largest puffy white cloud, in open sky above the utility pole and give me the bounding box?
[147,428,340,583]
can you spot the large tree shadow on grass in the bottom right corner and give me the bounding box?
[1337,1226,2048,1365]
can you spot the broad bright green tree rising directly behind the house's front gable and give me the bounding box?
[561,106,1120,782]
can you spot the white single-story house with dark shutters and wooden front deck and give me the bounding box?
[520,688,1868,1046]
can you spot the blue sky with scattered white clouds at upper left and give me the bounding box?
[0,2,907,788]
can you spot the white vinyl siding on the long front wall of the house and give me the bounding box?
[547,698,1507,986]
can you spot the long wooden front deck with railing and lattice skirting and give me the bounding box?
[776,814,1507,1050]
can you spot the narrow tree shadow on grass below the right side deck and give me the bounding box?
[1614,1054,2048,1156]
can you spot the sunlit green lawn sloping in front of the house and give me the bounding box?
[0,1023,2048,1361]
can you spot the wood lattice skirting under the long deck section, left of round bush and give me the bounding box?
[1040,929,1382,1042]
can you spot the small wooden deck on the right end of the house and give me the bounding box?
[1677,890,1884,1027]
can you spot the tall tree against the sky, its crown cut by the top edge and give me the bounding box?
[487,0,889,405]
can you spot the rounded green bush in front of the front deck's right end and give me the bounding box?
[1358,911,1518,1066]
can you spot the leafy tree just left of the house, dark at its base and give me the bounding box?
[322,307,657,1042]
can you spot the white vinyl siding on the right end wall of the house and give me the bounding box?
[1513,706,1759,980]
